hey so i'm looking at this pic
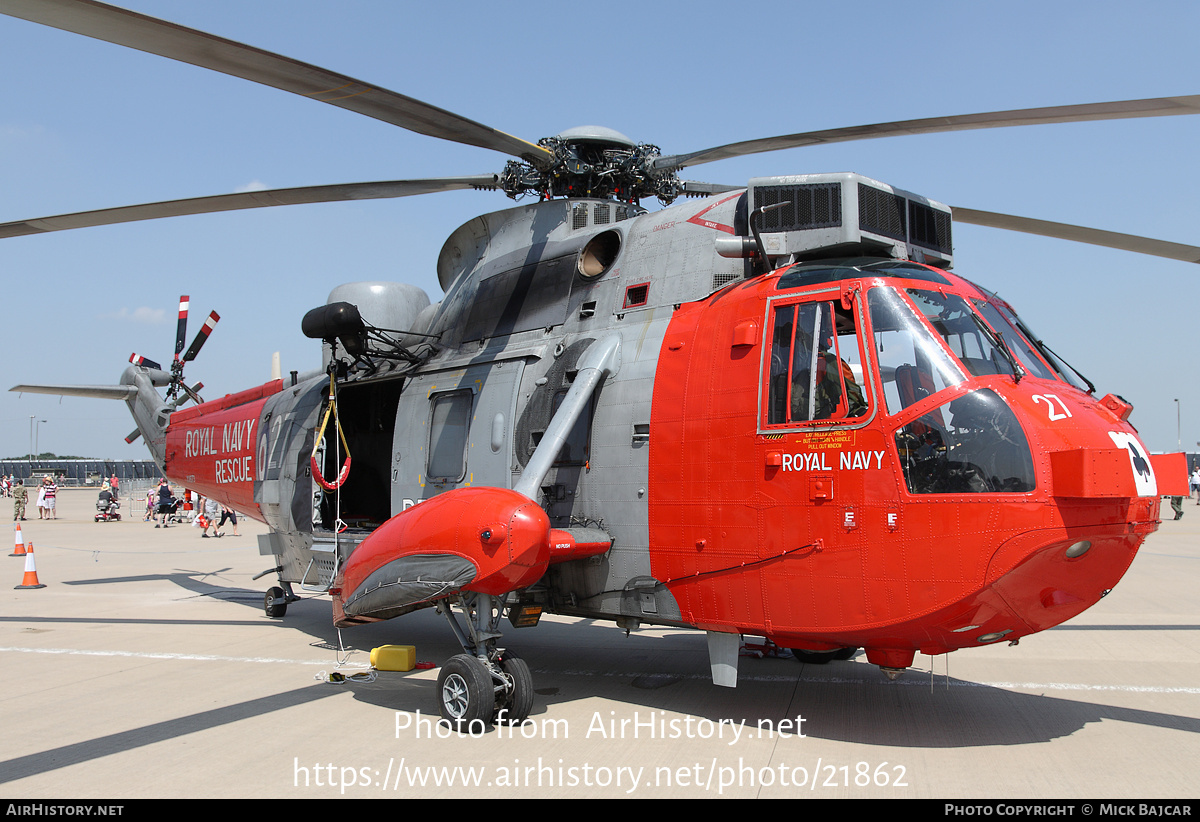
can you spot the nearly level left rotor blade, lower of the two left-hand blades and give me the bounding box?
[0,174,497,239]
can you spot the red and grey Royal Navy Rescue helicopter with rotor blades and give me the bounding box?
[0,0,1200,724]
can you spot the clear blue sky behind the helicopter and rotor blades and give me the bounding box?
[0,0,1200,458]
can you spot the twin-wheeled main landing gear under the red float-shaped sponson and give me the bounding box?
[438,594,533,731]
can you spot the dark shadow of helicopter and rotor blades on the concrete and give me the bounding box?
[0,569,1200,784]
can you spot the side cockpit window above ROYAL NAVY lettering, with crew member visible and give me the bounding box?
[764,301,868,425]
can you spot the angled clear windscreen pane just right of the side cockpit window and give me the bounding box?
[866,287,965,414]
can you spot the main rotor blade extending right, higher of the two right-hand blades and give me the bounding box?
[654,95,1200,169]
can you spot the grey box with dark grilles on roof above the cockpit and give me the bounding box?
[749,172,954,269]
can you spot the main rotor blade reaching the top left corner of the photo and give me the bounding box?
[0,0,553,166]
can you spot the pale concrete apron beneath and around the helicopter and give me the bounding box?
[0,491,1200,799]
